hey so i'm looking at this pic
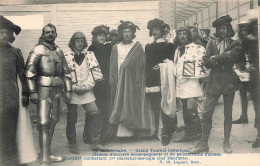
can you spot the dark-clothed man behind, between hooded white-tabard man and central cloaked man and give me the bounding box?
[87,25,112,143]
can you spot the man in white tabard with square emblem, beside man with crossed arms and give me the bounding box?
[174,27,205,142]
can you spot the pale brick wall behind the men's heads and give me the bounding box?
[0,1,159,60]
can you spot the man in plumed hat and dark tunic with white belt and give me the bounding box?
[145,19,177,146]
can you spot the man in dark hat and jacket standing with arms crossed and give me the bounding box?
[190,15,241,154]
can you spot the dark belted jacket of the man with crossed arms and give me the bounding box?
[203,39,241,94]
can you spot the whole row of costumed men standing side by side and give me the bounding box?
[0,8,260,166]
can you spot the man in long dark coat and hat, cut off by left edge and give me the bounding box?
[0,16,29,166]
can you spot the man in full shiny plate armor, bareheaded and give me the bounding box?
[26,24,72,166]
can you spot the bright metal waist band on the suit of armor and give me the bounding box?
[38,76,63,87]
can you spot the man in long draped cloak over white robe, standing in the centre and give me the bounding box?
[109,21,152,137]
